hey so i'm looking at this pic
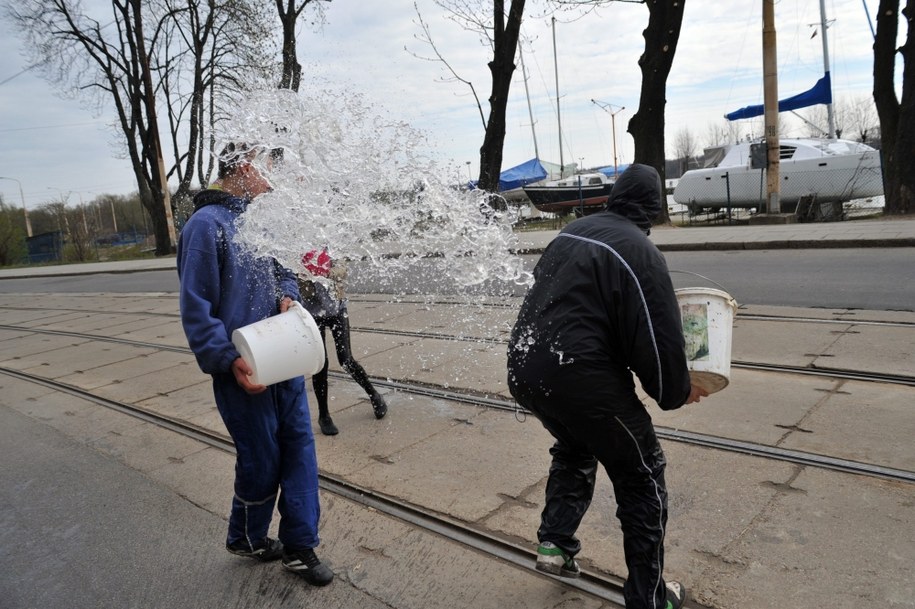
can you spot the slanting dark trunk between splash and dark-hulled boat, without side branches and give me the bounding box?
[478,0,525,204]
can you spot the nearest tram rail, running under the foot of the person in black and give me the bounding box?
[0,367,625,607]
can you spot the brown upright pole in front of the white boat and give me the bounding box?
[763,0,781,214]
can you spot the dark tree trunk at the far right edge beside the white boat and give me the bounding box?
[874,0,915,214]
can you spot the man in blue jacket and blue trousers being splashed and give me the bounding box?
[178,144,334,586]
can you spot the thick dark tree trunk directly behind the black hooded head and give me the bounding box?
[627,0,686,224]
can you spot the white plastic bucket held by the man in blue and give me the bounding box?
[232,302,324,385]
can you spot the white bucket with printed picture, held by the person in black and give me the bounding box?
[675,288,737,393]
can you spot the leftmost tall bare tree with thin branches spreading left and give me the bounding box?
[7,0,172,255]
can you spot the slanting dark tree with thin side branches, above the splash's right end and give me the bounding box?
[417,0,525,195]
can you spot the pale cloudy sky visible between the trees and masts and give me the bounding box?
[0,0,888,208]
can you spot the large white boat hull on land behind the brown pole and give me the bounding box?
[673,150,883,212]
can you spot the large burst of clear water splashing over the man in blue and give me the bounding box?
[220,90,531,287]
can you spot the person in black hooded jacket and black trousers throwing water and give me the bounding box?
[508,165,708,609]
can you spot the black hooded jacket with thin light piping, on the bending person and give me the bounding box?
[508,165,690,410]
